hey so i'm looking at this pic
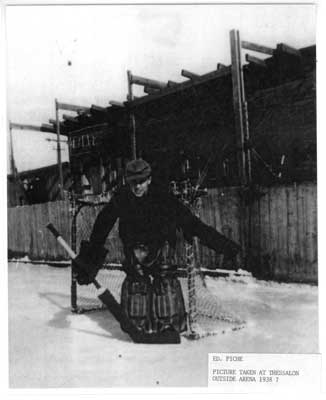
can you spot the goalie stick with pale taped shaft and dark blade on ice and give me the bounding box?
[46,223,180,344]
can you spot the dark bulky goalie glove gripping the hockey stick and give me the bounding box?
[73,240,107,285]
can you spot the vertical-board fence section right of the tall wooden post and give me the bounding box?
[250,183,318,283]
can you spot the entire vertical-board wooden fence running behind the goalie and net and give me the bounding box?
[8,183,318,283]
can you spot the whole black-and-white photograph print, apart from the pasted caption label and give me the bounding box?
[4,2,321,392]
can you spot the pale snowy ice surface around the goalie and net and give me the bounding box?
[8,262,318,388]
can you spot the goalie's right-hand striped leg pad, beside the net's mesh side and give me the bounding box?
[152,275,187,333]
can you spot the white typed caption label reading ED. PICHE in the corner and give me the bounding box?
[208,353,321,393]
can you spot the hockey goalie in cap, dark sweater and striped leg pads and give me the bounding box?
[75,159,240,335]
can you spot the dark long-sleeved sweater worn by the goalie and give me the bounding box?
[90,185,240,257]
